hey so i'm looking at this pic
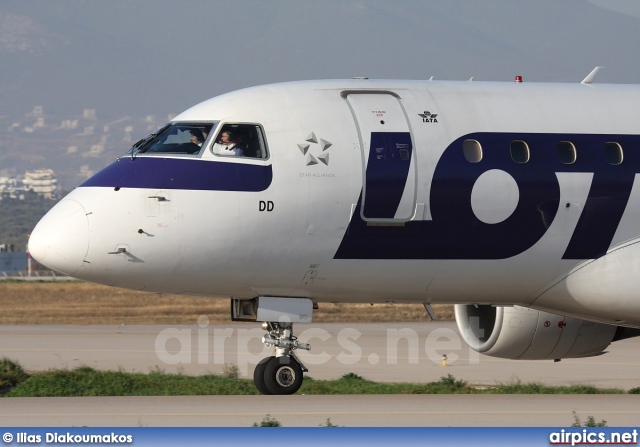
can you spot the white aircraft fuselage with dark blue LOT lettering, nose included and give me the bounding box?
[30,80,640,326]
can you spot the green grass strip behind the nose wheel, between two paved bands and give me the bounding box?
[0,359,640,397]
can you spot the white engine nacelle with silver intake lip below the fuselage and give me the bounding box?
[455,304,616,360]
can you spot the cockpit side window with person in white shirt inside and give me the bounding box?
[211,124,268,159]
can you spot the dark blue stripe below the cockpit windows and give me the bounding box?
[80,157,273,192]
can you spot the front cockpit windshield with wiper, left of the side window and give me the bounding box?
[132,123,213,155]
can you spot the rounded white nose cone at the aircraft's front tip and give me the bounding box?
[29,199,89,276]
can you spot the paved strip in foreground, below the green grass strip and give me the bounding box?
[5,394,640,427]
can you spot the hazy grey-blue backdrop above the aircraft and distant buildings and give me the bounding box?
[0,0,640,119]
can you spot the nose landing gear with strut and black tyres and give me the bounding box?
[253,321,310,394]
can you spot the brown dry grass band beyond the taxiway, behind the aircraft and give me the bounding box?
[0,282,453,325]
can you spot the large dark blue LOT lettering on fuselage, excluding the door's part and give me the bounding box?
[335,132,640,259]
